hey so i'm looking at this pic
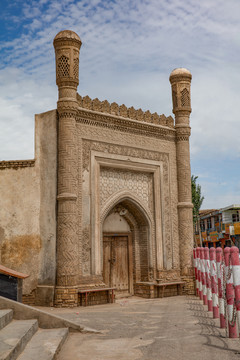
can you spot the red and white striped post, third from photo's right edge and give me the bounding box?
[216,247,226,329]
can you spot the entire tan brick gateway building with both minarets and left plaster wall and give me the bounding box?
[0,30,193,306]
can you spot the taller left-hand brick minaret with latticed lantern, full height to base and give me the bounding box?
[53,30,82,306]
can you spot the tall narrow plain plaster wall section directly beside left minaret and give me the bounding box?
[35,110,57,286]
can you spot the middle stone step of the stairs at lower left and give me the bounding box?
[0,320,38,360]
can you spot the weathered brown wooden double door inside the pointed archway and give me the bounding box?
[103,234,132,293]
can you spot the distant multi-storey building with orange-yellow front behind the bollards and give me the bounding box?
[195,204,240,248]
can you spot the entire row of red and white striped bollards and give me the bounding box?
[193,246,240,338]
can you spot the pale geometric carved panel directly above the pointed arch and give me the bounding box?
[100,167,153,210]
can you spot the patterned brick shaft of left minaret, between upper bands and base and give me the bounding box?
[57,112,79,286]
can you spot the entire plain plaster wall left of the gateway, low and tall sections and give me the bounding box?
[0,110,57,296]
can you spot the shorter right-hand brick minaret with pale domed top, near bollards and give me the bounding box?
[169,68,193,282]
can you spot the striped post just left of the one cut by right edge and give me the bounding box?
[224,247,238,338]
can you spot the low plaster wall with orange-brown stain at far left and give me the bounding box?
[0,166,39,293]
